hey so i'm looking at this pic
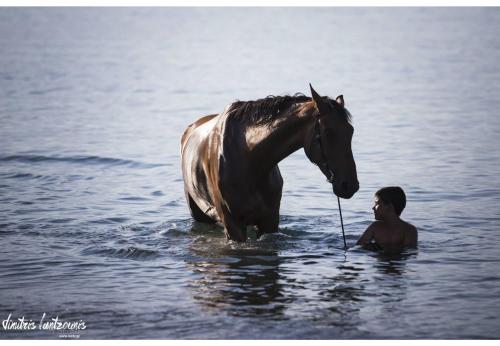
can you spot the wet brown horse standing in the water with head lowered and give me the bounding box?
[181,86,359,242]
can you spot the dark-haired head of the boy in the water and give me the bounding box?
[372,186,406,220]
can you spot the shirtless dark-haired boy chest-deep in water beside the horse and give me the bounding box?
[356,186,418,253]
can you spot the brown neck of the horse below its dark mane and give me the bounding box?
[246,103,314,176]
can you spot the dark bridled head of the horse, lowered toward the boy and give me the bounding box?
[304,85,359,198]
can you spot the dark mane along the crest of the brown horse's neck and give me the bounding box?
[228,93,351,125]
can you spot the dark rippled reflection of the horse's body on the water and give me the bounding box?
[188,249,286,319]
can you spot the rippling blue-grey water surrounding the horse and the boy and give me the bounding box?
[0,8,500,339]
